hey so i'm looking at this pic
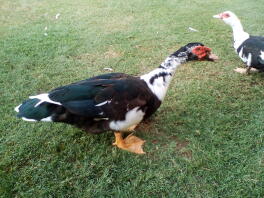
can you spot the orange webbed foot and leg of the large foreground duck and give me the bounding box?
[113,132,145,154]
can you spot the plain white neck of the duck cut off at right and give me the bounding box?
[231,19,249,49]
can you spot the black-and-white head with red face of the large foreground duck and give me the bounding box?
[172,43,218,61]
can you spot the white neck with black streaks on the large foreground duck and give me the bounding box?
[140,55,187,101]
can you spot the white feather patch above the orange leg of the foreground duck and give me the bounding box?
[109,107,145,131]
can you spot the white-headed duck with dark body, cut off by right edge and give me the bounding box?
[213,11,264,73]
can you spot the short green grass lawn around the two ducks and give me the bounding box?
[0,0,264,198]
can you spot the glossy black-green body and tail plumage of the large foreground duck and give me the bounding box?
[19,73,161,133]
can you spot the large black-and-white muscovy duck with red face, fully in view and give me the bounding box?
[15,43,217,154]
